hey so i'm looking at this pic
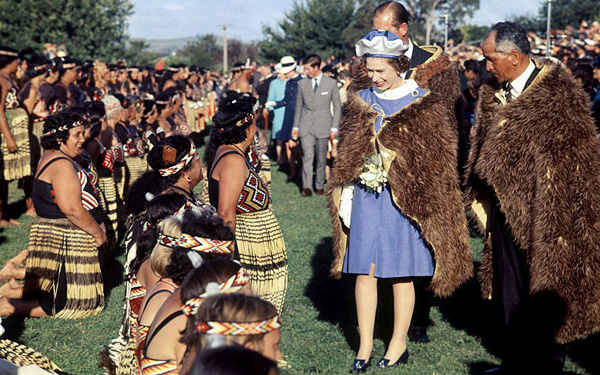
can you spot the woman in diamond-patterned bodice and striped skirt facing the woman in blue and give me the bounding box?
[205,94,287,313]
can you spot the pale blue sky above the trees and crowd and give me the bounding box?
[129,0,540,41]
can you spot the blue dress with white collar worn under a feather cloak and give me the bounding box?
[343,80,434,278]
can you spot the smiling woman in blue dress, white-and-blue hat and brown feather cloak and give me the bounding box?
[327,31,472,373]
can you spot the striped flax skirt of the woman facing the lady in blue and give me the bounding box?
[235,209,288,313]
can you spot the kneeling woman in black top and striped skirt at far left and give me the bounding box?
[0,111,106,319]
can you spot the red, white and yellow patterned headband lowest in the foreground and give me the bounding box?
[196,315,281,336]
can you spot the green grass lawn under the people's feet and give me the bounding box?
[0,165,600,375]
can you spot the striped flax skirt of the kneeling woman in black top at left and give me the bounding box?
[23,217,104,319]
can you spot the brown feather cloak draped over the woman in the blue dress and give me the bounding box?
[327,47,473,296]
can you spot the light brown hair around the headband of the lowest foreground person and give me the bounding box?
[184,293,277,362]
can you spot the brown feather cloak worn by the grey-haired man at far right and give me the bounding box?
[466,60,600,343]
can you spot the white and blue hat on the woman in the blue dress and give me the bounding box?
[356,30,408,59]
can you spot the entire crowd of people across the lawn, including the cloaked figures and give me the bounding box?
[0,1,600,375]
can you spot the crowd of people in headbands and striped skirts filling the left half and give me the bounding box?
[0,36,287,374]
